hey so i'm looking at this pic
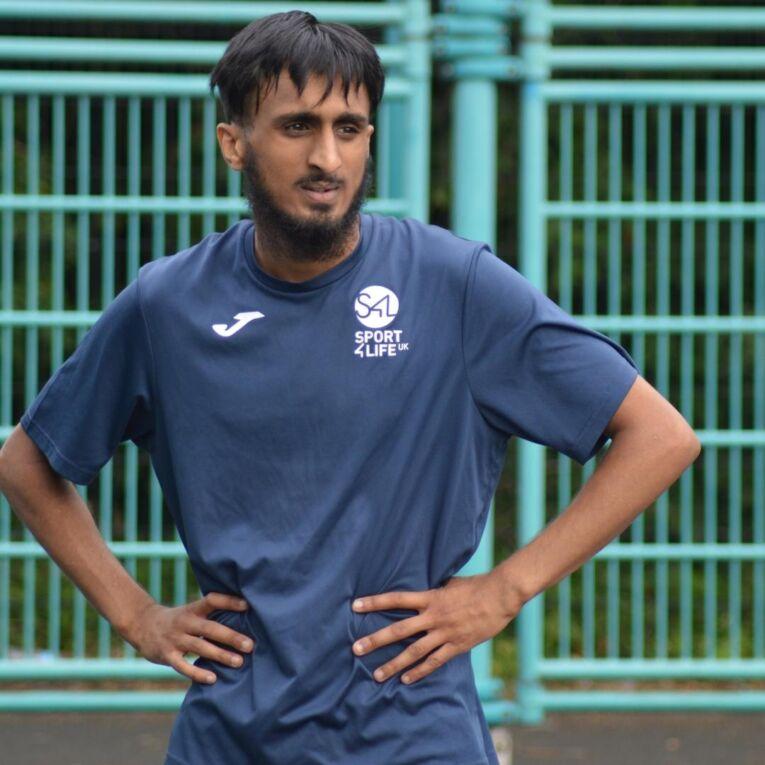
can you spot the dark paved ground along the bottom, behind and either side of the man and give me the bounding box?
[0,713,765,765]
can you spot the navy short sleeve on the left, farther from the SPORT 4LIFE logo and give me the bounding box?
[20,278,154,484]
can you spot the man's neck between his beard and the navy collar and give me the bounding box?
[253,216,361,282]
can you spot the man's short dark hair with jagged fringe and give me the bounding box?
[210,11,385,124]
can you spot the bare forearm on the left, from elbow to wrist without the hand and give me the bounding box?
[0,456,154,638]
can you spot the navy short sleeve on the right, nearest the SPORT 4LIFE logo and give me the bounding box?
[462,245,639,465]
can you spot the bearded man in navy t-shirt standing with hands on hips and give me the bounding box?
[0,12,699,765]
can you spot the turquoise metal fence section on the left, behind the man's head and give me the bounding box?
[0,0,430,710]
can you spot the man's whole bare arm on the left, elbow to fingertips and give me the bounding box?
[0,425,252,682]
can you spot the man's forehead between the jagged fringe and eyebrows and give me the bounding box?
[258,69,370,115]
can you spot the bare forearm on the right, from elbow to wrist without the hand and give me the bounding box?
[494,420,698,615]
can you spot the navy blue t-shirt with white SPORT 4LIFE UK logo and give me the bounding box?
[21,213,638,765]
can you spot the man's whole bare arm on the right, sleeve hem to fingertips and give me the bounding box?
[353,375,701,683]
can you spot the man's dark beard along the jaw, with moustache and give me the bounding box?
[242,147,374,263]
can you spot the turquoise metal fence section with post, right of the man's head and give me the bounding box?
[443,0,765,723]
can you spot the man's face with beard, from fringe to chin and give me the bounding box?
[221,70,374,260]
